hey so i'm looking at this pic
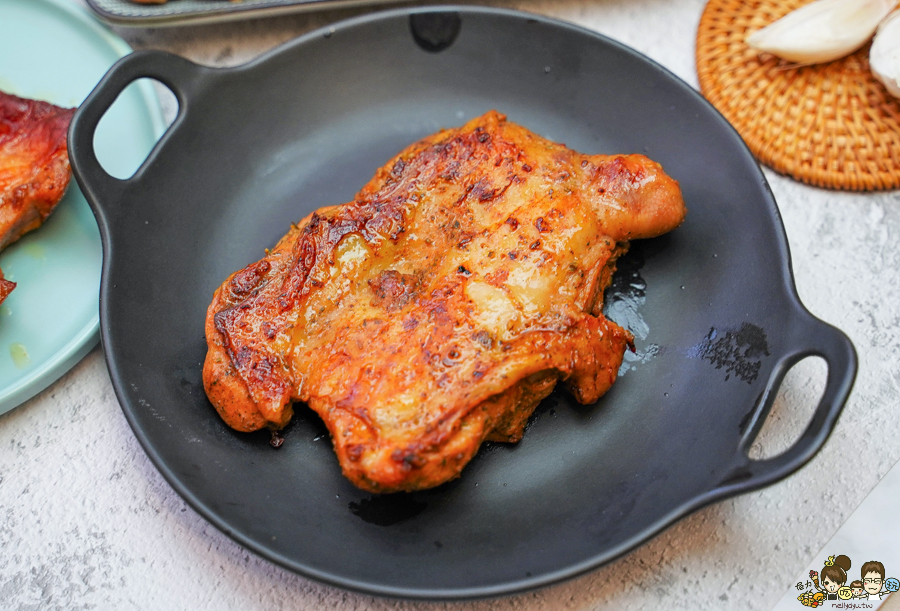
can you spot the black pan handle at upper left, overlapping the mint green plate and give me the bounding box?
[68,51,206,222]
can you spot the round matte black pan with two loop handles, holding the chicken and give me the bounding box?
[69,7,856,599]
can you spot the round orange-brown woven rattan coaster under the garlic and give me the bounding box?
[697,0,900,191]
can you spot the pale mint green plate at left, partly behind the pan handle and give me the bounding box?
[0,0,165,414]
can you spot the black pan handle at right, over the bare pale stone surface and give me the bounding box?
[713,313,858,496]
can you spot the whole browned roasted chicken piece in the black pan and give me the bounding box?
[203,111,685,492]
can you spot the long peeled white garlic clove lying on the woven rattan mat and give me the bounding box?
[746,0,897,64]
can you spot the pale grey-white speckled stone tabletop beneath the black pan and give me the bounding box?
[0,0,900,611]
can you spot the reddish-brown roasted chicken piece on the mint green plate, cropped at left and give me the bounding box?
[0,91,75,249]
